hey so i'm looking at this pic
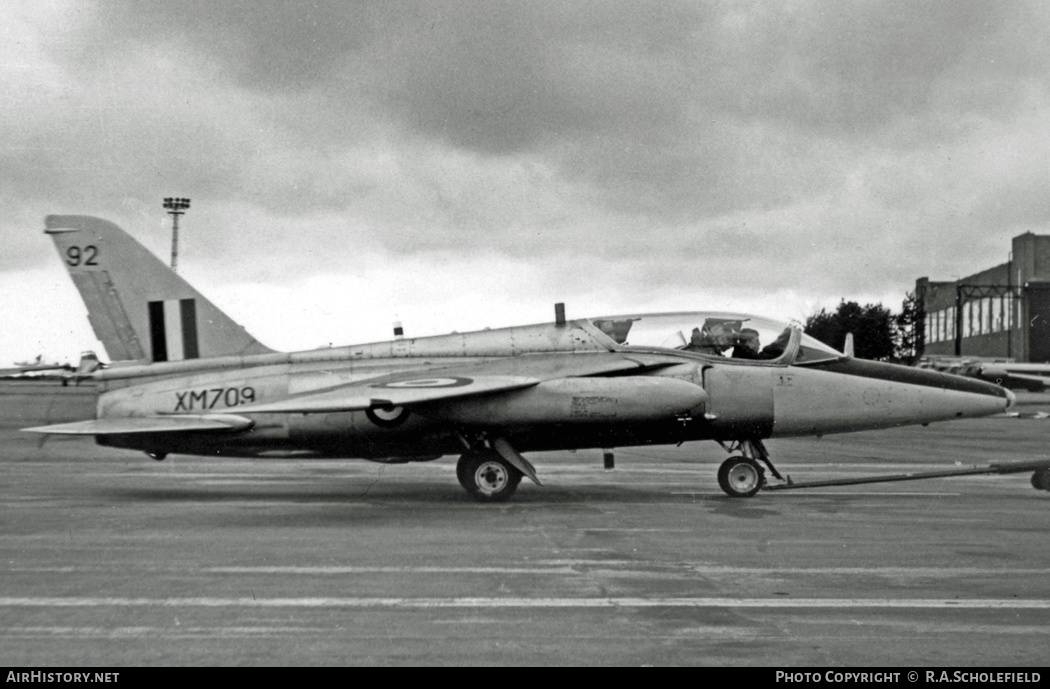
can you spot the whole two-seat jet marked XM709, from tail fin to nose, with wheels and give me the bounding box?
[26,215,1013,501]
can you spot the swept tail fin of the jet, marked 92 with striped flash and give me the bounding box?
[44,215,272,361]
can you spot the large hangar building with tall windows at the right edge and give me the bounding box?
[916,232,1050,362]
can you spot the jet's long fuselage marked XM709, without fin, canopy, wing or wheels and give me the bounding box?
[98,325,1009,461]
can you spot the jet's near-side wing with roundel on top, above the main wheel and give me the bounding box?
[233,374,540,411]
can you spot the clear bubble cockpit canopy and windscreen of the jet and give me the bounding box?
[590,312,845,363]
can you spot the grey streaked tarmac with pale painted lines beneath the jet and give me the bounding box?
[0,384,1050,667]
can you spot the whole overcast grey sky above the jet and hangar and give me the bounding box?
[0,0,1050,366]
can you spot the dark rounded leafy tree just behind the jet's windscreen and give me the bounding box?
[805,299,897,361]
